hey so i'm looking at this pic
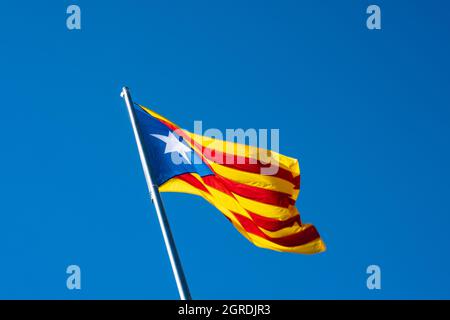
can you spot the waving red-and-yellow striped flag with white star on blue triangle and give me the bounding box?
[134,104,325,254]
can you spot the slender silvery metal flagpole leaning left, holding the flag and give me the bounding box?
[121,87,191,300]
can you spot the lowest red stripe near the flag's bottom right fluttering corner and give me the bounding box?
[234,213,320,247]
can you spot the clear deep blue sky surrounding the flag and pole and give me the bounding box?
[0,0,450,299]
